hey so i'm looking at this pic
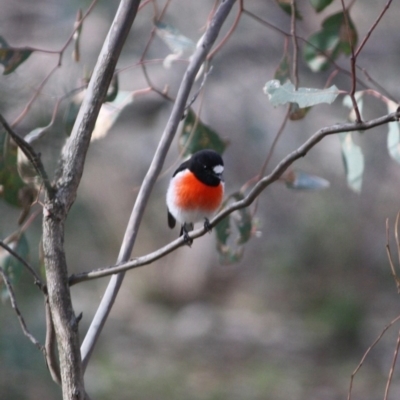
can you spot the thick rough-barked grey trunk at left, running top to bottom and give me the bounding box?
[43,0,140,400]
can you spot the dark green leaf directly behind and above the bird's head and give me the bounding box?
[178,110,228,157]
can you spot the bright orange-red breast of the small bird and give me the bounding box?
[175,171,224,212]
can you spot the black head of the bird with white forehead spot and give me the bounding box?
[188,150,224,186]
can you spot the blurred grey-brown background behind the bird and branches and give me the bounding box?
[0,0,400,400]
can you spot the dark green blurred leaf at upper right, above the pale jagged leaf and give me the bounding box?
[303,12,357,72]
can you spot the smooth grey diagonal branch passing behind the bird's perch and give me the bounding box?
[81,0,236,368]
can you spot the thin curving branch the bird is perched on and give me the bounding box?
[69,111,400,285]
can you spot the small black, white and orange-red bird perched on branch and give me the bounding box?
[166,149,224,247]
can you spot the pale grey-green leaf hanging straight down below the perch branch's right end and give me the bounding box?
[339,132,364,193]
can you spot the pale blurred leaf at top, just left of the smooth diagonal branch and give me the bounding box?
[154,21,196,68]
